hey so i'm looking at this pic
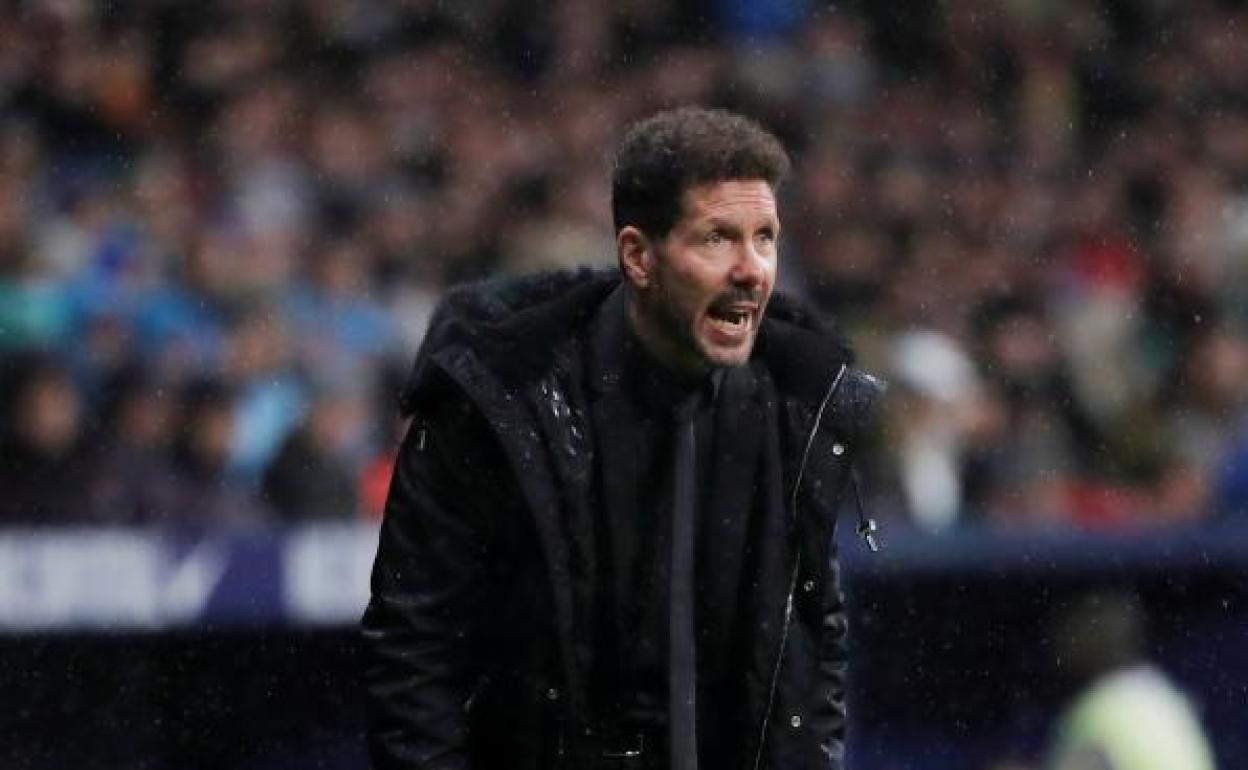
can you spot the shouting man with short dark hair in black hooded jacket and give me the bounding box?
[363,109,877,770]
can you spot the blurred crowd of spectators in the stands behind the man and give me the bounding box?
[0,0,1248,530]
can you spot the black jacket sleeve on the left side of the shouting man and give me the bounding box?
[362,396,501,770]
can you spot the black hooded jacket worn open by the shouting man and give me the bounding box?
[363,271,879,770]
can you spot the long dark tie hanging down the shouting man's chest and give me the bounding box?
[668,397,699,770]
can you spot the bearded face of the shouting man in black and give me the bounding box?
[625,180,780,371]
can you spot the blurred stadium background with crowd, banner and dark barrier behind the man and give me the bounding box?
[0,0,1248,770]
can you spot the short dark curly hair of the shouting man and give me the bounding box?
[612,107,790,237]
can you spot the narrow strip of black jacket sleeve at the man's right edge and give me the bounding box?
[814,545,849,770]
